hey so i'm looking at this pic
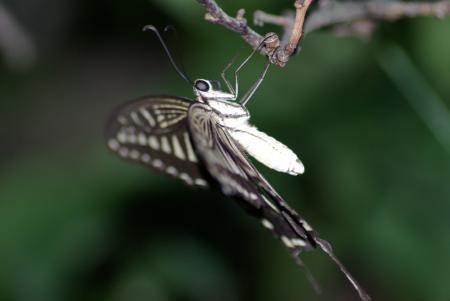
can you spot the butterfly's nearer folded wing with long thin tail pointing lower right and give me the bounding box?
[188,103,370,300]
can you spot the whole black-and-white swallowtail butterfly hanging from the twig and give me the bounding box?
[106,26,370,300]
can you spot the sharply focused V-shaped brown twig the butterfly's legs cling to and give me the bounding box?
[198,0,313,67]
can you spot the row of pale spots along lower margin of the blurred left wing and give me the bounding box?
[108,139,208,187]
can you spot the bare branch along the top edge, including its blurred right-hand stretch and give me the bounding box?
[197,0,450,67]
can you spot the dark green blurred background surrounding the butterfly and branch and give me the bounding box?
[0,0,450,301]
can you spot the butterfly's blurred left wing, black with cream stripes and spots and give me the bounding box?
[106,96,209,187]
